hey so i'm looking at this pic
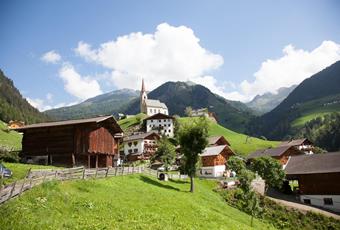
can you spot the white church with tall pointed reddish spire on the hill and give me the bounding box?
[140,79,169,116]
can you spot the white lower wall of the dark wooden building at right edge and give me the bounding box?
[300,195,340,212]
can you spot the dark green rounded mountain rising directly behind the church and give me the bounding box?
[125,82,254,132]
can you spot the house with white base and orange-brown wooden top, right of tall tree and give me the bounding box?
[200,145,234,177]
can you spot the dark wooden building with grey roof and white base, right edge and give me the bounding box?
[285,152,340,212]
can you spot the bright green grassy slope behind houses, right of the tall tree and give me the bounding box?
[179,117,279,155]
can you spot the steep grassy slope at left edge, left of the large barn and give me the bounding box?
[0,121,22,150]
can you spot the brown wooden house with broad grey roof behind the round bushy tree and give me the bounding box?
[247,145,304,168]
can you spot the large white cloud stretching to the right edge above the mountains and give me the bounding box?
[236,41,340,100]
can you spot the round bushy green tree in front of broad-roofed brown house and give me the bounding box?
[250,157,285,191]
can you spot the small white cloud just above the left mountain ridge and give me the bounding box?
[59,64,103,100]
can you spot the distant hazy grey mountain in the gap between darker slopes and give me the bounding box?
[246,85,296,115]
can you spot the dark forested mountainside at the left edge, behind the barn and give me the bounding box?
[0,70,48,124]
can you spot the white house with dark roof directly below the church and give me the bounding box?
[144,113,175,137]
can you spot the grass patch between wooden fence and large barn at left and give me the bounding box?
[3,163,58,184]
